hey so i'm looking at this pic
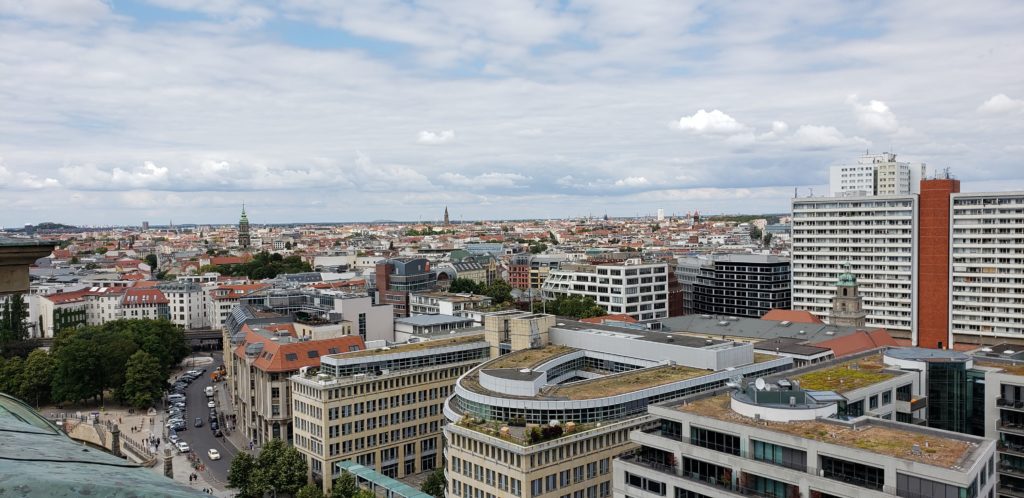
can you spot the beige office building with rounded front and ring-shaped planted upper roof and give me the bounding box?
[443,312,792,498]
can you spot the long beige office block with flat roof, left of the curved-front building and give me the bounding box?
[290,332,489,490]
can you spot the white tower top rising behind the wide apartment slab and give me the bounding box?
[828,153,926,197]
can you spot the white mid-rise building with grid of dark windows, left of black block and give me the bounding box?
[542,258,670,321]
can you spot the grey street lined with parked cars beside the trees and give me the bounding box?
[178,351,238,486]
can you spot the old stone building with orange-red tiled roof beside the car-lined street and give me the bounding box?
[225,320,366,445]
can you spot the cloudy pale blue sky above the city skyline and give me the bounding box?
[0,0,1024,226]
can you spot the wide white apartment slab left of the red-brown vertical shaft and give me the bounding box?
[792,195,918,335]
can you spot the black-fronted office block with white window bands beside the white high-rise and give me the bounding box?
[684,254,792,318]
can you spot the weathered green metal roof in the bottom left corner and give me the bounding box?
[0,393,209,498]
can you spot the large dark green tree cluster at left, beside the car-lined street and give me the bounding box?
[0,320,189,409]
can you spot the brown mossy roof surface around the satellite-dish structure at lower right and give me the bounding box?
[677,393,974,468]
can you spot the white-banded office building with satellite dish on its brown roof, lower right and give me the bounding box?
[612,379,996,498]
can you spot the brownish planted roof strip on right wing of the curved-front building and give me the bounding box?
[547,365,712,400]
